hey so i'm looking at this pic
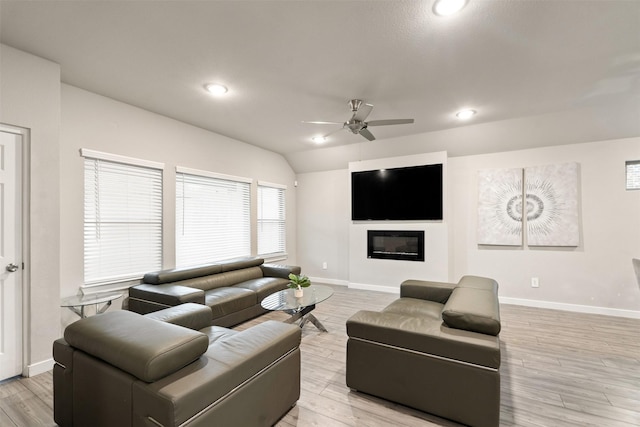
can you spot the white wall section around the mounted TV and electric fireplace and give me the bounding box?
[297,152,449,291]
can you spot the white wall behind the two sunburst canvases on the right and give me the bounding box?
[449,138,640,314]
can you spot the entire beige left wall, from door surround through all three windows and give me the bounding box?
[0,45,297,375]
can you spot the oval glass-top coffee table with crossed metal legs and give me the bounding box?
[260,285,333,332]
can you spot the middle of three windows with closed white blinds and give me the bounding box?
[176,168,251,267]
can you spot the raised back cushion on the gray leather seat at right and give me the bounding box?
[442,287,500,335]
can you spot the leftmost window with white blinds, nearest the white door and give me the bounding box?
[81,149,164,286]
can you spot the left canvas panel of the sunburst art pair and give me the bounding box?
[478,168,523,246]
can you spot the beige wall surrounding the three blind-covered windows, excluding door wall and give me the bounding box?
[60,84,297,326]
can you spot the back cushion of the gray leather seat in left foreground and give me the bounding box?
[64,310,209,382]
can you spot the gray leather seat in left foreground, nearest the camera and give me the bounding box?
[53,303,301,427]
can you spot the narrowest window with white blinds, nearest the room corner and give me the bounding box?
[258,182,287,258]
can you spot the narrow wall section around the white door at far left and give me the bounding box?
[0,45,60,375]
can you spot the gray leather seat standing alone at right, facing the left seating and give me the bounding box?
[346,276,501,427]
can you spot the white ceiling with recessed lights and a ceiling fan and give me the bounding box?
[0,0,640,172]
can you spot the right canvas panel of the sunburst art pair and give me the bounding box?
[524,163,580,246]
